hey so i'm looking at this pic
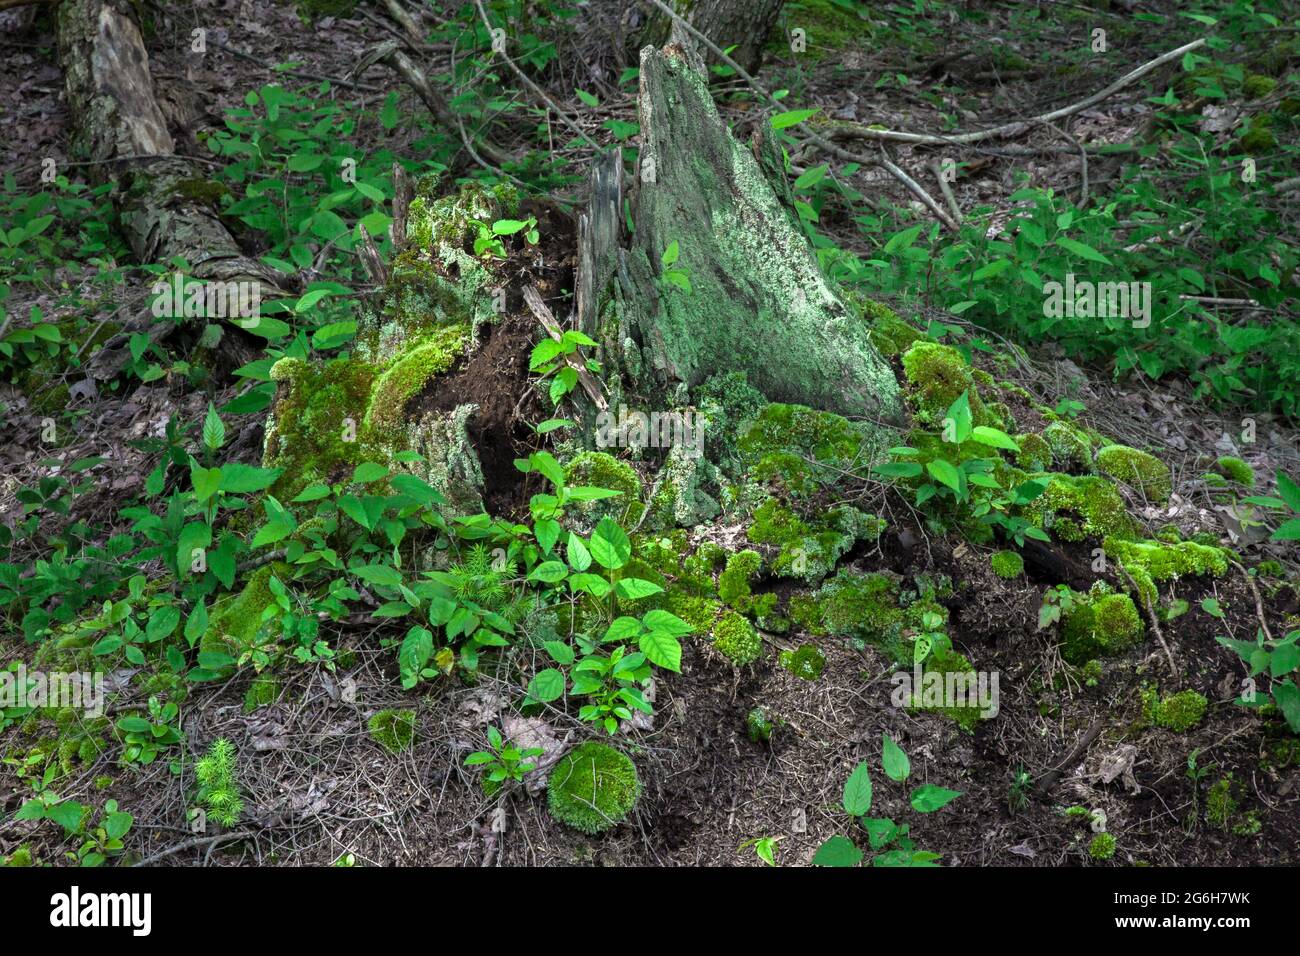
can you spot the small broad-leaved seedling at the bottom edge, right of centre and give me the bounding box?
[813,735,961,866]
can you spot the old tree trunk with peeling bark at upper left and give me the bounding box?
[59,0,280,377]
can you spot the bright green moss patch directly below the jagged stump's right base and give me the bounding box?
[737,403,884,496]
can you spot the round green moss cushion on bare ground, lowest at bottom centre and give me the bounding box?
[546,741,641,835]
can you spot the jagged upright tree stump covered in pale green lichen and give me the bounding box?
[590,44,901,421]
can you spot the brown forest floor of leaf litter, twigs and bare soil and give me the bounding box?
[0,0,1300,866]
